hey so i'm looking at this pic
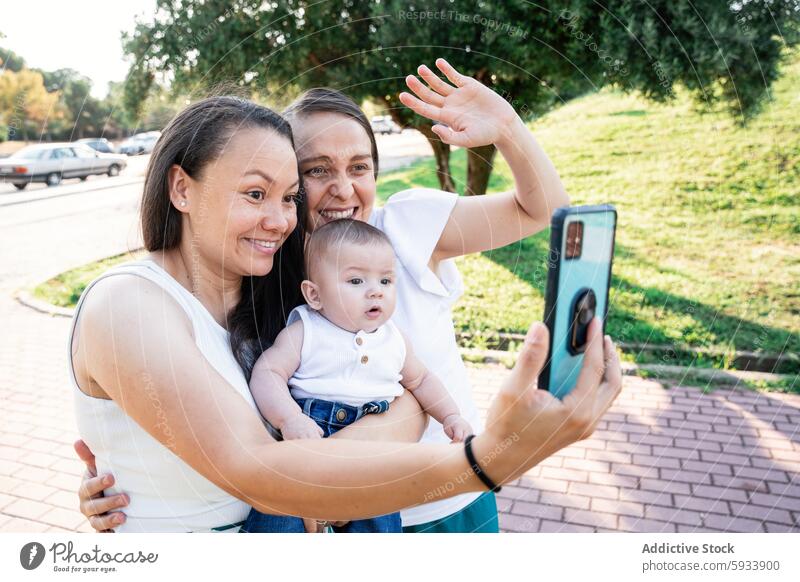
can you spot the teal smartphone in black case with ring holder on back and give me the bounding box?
[539,204,617,398]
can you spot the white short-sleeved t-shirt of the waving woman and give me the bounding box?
[368,188,483,526]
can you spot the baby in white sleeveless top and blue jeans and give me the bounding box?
[247,219,472,532]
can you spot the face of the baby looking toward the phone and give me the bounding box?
[314,243,396,333]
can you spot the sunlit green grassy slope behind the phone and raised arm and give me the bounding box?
[379,54,800,368]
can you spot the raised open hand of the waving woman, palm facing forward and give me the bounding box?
[400,59,519,147]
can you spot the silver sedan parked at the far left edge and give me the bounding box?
[0,143,128,190]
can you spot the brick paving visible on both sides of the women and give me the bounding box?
[0,297,800,532]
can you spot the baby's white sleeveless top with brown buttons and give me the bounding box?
[287,305,406,406]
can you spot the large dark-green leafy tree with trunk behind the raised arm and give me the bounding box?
[120,0,800,194]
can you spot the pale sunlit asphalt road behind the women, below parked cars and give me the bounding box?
[0,132,430,294]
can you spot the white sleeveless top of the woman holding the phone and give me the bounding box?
[67,260,256,532]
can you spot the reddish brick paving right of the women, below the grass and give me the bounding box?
[472,368,800,532]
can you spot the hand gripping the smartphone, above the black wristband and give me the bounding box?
[475,318,622,483]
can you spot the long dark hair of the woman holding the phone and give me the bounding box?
[141,95,306,380]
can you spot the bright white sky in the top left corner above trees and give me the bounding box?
[0,0,156,98]
